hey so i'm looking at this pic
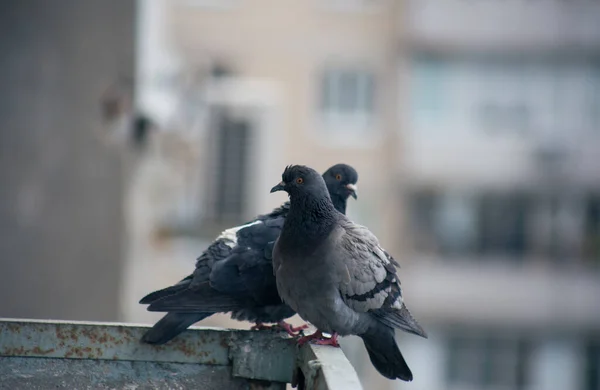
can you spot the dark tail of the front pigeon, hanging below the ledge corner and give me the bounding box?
[360,325,412,382]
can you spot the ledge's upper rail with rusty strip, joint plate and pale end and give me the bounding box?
[0,318,362,390]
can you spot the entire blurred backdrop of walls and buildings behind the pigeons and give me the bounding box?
[0,0,600,390]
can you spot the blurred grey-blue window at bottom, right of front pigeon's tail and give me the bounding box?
[446,332,531,390]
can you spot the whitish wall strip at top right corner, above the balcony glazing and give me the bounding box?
[404,0,600,49]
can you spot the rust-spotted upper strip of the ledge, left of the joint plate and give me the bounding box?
[0,318,286,365]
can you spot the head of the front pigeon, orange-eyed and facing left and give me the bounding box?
[271,165,329,198]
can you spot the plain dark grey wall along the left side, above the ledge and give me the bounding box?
[0,0,135,320]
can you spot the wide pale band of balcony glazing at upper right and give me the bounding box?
[410,53,600,135]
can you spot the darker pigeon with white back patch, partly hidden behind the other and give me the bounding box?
[140,164,358,344]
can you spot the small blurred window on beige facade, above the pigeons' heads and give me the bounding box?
[321,70,375,127]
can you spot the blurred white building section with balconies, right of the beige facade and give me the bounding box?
[399,0,600,390]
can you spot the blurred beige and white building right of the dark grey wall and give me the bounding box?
[118,0,600,390]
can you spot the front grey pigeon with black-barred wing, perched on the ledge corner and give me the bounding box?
[271,165,427,381]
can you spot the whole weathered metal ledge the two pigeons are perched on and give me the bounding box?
[0,319,361,390]
